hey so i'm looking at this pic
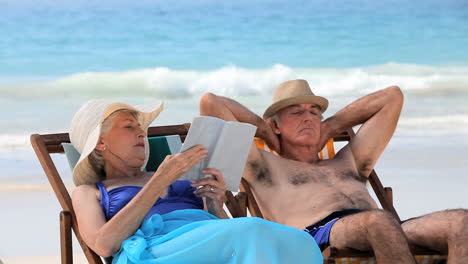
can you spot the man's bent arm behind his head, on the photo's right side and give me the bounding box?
[321,86,403,176]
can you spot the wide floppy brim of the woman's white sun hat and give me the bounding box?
[73,102,164,186]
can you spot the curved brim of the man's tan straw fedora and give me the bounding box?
[263,95,328,119]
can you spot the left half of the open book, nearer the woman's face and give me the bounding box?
[180,116,226,182]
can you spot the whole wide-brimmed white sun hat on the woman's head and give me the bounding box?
[70,99,163,186]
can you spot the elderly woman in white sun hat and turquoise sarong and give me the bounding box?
[70,100,322,263]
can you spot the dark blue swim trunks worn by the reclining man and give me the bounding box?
[304,209,362,251]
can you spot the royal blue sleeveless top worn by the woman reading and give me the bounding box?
[96,181,203,221]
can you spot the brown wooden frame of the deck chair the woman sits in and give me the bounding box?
[31,124,227,264]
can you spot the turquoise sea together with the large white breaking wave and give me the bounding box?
[0,0,468,102]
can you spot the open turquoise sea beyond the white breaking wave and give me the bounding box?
[0,0,468,78]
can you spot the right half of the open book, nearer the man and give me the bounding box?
[207,122,257,192]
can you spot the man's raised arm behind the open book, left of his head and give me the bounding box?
[200,93,280,152]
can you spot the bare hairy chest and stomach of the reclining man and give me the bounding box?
[247,154,376,226]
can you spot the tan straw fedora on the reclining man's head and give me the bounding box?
[263,80,328,119]
